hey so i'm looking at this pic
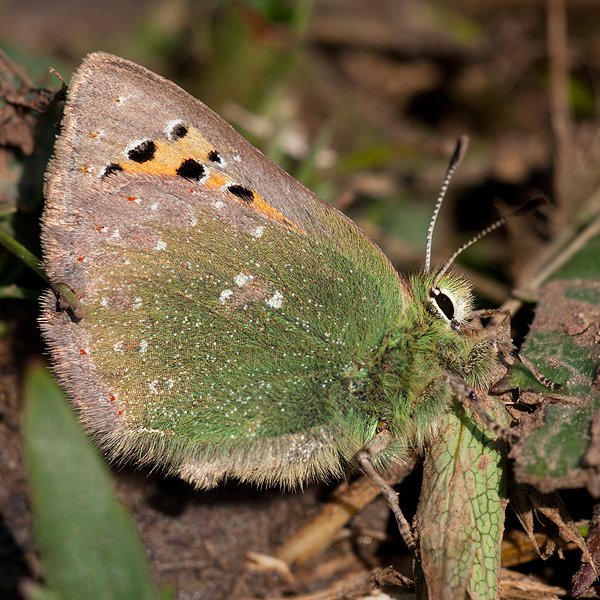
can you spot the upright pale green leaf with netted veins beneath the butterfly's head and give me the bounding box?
[417,399,507,599]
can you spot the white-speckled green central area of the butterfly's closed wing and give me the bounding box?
[79,204,402,486]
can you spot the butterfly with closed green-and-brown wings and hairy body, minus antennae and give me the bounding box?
[41,53,498,488]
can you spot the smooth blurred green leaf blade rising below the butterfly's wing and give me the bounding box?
[23,364,163,600]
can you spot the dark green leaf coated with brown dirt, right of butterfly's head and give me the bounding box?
[509,230,600,492]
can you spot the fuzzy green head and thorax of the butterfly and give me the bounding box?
[356,272,497,446]
